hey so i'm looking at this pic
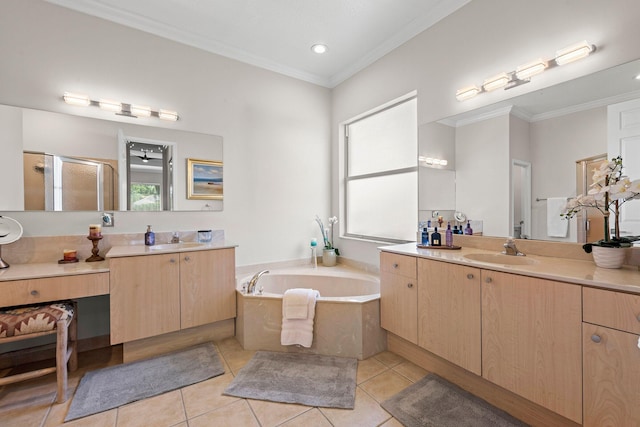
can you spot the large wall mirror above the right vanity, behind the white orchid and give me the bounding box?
[418,60,640,242]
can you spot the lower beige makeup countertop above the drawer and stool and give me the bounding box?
[0,261,109,282]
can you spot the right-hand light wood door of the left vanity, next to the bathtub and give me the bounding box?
[180,248,236,329]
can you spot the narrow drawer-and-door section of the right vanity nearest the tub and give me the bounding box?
[380,252,418,344]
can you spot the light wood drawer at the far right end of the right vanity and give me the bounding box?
[582,287,640,334]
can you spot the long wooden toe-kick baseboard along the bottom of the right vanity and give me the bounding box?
[387,333,580,427]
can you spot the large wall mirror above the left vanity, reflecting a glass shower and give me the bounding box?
[0,105,223,211]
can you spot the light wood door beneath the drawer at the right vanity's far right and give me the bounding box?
[582,323,640,427]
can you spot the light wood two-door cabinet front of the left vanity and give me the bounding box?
[110,248,236,344]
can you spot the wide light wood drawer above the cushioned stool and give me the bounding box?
[0,273,109,307]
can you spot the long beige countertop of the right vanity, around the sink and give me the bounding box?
[379,242,640,294]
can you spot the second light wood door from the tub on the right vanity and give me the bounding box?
[418,259,482,375]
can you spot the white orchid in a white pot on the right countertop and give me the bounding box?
[560,156,640,268]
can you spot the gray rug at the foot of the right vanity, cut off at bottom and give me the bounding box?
[382,374,527,427]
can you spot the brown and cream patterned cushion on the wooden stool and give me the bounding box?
[0,301,73,338]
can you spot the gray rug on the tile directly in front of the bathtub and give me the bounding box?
[224,351,358,409]
